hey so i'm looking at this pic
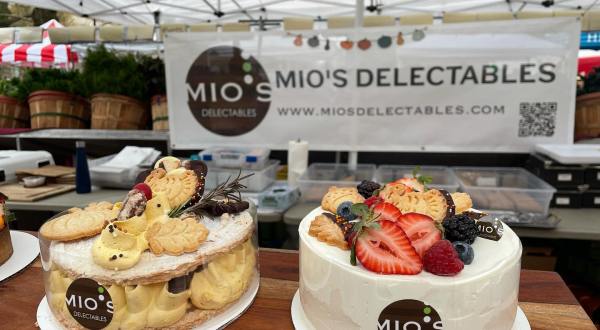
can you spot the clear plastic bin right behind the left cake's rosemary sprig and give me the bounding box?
[205,160,279,192]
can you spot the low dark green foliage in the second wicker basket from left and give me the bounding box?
[17,69,88,100]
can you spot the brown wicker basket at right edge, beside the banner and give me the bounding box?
[575,92,600,140]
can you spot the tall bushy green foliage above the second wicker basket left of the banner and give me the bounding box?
[83,45,148,101]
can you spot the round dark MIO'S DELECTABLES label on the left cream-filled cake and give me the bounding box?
[65,278,114,330]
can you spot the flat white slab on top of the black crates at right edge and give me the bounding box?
[535,144,600,164]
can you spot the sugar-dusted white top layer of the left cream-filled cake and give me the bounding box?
[43,211,254,283]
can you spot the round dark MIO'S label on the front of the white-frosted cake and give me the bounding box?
[377,299,443,330]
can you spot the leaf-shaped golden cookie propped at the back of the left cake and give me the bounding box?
[144,168,199,207]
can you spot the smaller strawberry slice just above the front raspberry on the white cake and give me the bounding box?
[397,213,442,257]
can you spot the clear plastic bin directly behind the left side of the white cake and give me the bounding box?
[298,163,376,201]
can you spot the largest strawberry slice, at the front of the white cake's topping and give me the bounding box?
[355,220,423,275]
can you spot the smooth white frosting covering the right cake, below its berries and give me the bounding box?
[298,208,522,330]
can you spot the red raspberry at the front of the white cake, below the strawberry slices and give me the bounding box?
[423,240,464,276]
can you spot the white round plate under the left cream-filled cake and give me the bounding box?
[37,274,259,330]
